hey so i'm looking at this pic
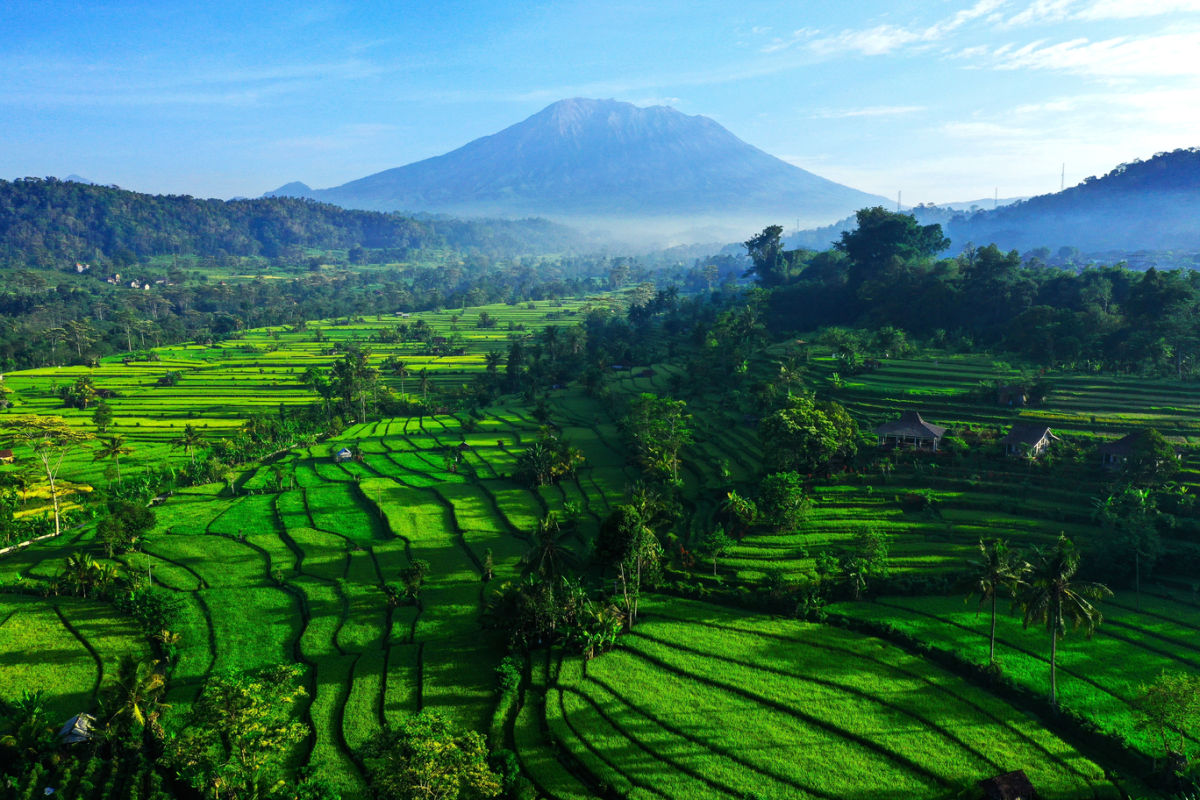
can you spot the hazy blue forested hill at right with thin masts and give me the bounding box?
[940,148,1200,253]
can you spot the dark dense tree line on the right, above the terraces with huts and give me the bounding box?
[746,207,1200,379]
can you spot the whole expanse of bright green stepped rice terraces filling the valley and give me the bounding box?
[0,257,1200,798]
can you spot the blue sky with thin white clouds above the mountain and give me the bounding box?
[0,0,1200,205]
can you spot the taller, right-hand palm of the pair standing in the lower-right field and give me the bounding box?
[1021,534,1112,708]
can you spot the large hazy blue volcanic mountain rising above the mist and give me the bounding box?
[272,98,887,240]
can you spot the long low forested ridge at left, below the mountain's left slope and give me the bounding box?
[0,178,583,266]
